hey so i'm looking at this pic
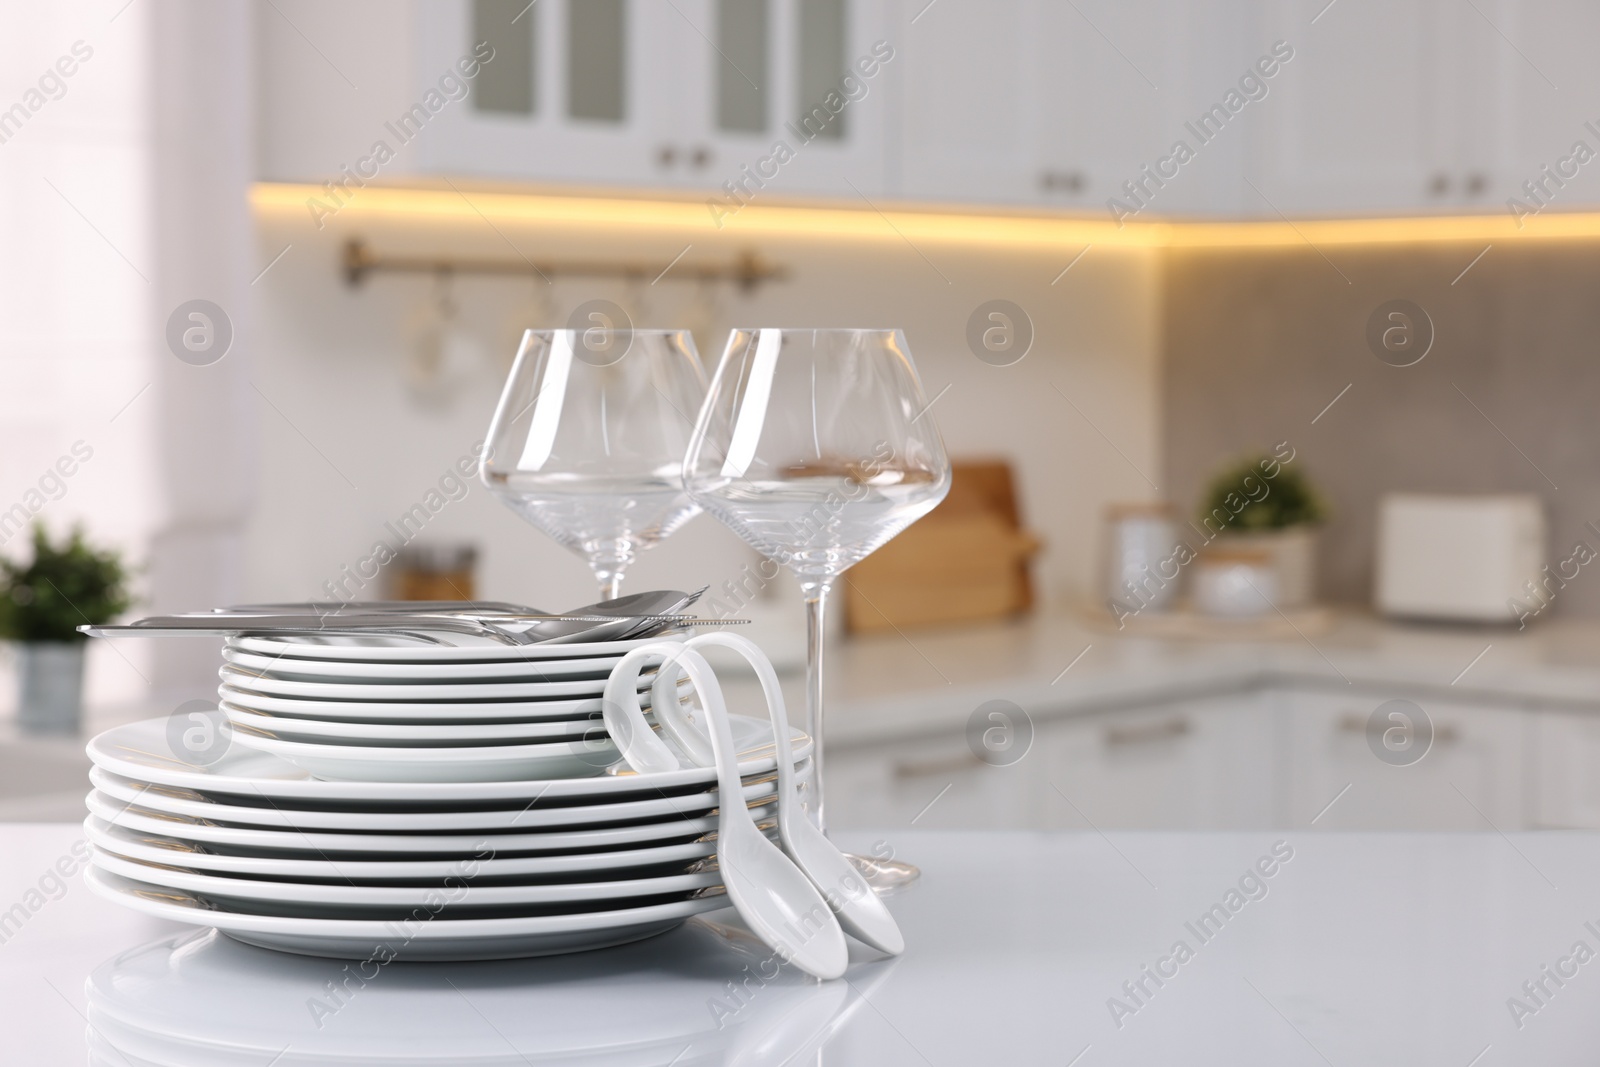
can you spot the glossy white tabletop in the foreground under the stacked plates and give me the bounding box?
[9,825,1600,1067]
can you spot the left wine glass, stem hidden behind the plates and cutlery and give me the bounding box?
[478,326,706,600]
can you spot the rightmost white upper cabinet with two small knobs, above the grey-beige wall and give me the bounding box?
[1248,0,1600,214]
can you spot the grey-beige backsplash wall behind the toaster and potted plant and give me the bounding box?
[1162,242,1600,617]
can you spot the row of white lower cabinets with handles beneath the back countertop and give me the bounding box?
[827,683,1561,830]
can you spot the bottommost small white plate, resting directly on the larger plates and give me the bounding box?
[234,729,619,782]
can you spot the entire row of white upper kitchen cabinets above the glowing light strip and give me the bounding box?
[256,0,1600,219]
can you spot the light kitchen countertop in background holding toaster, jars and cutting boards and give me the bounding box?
[806,613,1600,745]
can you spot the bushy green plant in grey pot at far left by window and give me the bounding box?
[0,523,130,733]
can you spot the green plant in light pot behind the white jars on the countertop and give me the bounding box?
[1198,453,1326,608]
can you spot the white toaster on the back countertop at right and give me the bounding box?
[1373,493,1549,622]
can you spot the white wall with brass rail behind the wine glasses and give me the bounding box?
[245,197,1160,627]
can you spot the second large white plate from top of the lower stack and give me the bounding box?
[90,766,776,833]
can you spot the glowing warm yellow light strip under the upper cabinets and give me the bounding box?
[251,182,1600,250]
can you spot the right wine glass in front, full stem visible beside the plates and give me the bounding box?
[683,330,950,886]
